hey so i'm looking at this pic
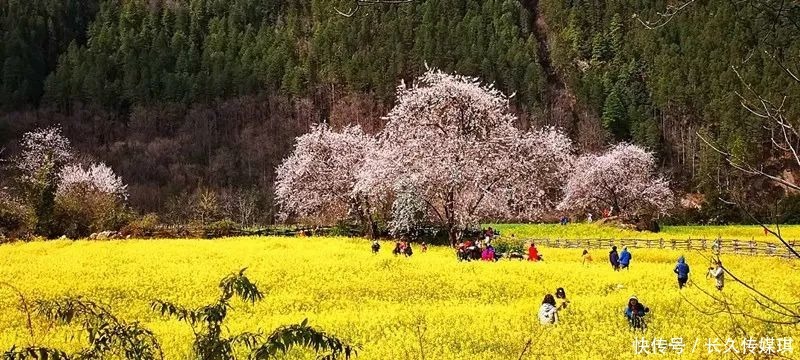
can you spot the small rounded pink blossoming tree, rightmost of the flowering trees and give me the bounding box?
[559,143,674,217]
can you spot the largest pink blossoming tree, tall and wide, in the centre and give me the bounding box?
[354,70,572,243]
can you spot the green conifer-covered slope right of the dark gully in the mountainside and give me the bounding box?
[541,0,800,205]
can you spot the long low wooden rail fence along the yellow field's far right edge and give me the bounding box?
[523,239,797,258]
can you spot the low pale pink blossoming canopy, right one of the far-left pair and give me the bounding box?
[56,163,128,200]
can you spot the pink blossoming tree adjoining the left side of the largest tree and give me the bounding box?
[275,125,374,224]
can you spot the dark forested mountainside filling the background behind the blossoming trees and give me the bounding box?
[0,0,800,223]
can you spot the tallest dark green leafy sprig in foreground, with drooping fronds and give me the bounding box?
[152,268,353,360]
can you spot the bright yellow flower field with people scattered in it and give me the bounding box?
[0,237,800,360]
